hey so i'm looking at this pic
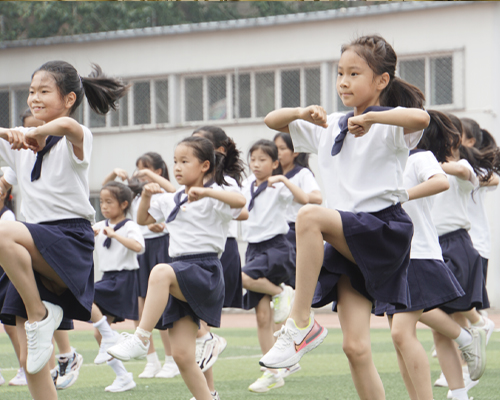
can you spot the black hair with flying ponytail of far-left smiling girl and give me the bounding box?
[31,61,130,114]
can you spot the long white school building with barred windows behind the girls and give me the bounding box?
[0,1,500,308]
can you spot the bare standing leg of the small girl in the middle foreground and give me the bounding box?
[169,316,212,400]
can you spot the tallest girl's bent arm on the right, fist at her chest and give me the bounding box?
[348,108,430,136]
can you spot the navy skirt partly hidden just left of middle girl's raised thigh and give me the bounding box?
[137,234,172,298]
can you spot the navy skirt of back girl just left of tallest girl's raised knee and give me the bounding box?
[242,235,295,310]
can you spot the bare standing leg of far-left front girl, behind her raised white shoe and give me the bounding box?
[16,317,57,400]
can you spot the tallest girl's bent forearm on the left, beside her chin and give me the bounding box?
[264,106,328,133]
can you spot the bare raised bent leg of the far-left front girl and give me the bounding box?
[0,221,66,323]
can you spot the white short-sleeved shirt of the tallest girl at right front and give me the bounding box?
[288,108,422,212]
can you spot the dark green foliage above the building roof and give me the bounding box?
[0,1,367,41]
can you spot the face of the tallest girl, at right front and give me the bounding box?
[337,49,389,114]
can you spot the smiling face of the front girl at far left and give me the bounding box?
[28,71,76,122]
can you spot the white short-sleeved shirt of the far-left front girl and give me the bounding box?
[0,125,95,223]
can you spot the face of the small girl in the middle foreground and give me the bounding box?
[174,143,210,187]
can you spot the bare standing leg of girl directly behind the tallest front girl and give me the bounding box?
[391,310,433,400]
